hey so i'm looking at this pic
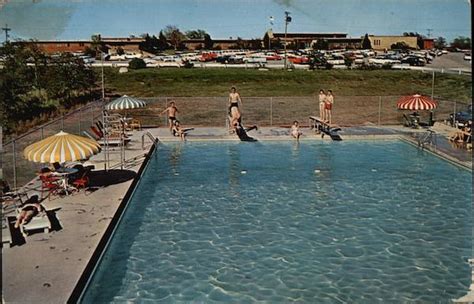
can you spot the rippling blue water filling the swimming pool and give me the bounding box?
[83,141,473,303]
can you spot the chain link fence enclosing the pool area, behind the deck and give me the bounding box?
[0,96,467,188]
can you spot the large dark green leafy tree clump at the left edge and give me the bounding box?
[0,41,95,134]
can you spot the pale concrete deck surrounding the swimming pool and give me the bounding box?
[2,126,474,303]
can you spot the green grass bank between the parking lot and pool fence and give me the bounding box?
[102,68,472,103]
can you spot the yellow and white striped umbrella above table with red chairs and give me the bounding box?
[23,131,100,163]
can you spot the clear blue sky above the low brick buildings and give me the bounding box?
[0,0,471,42]
